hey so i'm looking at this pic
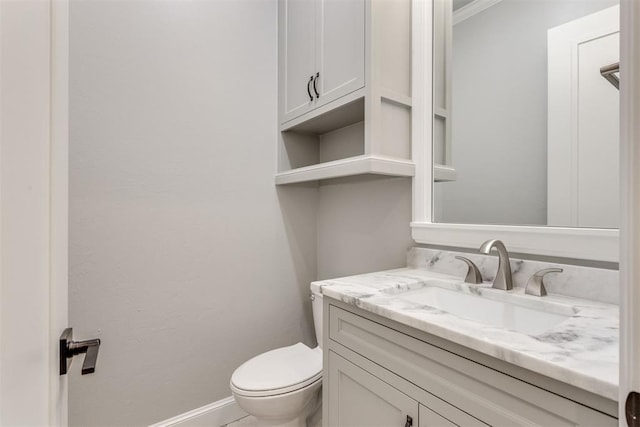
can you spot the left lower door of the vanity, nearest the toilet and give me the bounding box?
[325,352,419,427]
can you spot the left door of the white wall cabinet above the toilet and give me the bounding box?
[278,0,317,122]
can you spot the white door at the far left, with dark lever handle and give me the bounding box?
[0,0,68,426]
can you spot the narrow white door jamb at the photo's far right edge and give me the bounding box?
[618,1,640,426]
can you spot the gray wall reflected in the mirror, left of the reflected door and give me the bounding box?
[435,0,618,225]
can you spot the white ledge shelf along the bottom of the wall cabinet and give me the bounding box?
[275,155,415,185]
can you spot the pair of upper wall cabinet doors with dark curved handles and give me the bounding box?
[279,0,365,123]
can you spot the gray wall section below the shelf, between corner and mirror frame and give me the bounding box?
[318,176,413,279]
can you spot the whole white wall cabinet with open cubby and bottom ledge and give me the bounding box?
[276,0,415,184]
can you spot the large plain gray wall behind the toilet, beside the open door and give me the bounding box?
[69,1,318,426]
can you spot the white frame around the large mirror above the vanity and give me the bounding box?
[410,0,620,262]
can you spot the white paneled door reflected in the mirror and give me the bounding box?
[547,6,620,228]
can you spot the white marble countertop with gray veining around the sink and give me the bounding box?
[311,268,619,400]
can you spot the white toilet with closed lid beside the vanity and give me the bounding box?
[230,292,322,427]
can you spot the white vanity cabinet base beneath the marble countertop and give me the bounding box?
[323,297,618,427]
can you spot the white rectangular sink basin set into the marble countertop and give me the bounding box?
[399,286,575,335]
